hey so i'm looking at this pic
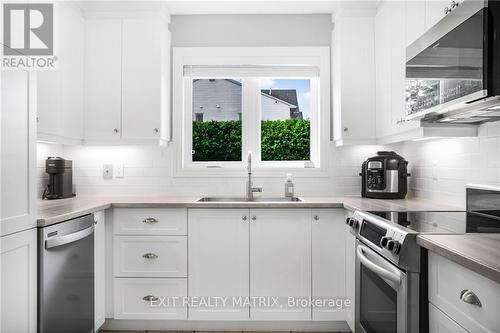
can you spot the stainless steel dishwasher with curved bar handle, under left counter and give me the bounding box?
[38,214,94,333]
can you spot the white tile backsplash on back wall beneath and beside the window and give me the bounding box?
[37,143,383,196]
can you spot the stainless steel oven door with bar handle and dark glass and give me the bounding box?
[355,240,418,333]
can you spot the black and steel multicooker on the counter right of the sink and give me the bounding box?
[360,151,410,199]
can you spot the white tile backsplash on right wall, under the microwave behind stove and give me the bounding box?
[391,122,500,207]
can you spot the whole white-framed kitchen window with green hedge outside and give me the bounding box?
[173,47,329,176]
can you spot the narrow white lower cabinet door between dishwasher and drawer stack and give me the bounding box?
[94,211,106,332]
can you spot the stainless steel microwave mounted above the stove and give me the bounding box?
[406,0,500,124]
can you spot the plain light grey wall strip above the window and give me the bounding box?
[170,14,332,47]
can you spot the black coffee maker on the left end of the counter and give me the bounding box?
[42,157,75,200]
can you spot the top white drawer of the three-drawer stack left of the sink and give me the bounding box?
[113,208,187,235]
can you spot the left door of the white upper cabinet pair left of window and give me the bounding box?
[85,19,122,141]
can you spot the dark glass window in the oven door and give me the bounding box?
[360,265,397,333]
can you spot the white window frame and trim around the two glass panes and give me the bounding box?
[172,47,331,176]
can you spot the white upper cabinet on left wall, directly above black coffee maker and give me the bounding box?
[37,2,84,143]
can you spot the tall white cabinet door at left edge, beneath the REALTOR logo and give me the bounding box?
[0,70,36,236]
